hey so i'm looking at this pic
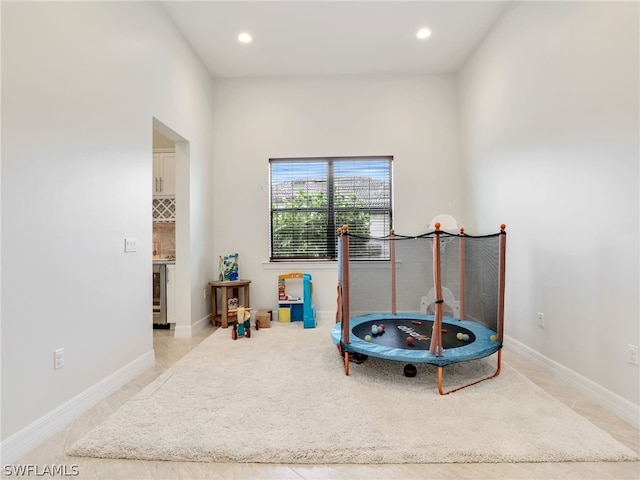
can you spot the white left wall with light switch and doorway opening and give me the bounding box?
[2,2,214,440]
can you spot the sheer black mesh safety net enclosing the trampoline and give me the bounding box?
[338,232,502,331]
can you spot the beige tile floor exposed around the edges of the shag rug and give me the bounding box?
[3,327,640,480]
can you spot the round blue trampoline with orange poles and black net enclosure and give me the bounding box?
[331,223,506,395]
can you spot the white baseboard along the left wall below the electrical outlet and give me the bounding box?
[0,350,156,465]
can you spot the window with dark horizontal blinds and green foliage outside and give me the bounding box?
[269,157,393,261]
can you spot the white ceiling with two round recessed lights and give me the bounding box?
[162,0,509,78]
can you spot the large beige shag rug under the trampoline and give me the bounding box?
[68,322,637,464]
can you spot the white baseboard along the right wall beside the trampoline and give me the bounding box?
[504,335,640,428]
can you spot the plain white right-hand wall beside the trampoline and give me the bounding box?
[460,2,640,404]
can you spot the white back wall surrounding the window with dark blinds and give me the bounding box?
[213,75,460,315]
